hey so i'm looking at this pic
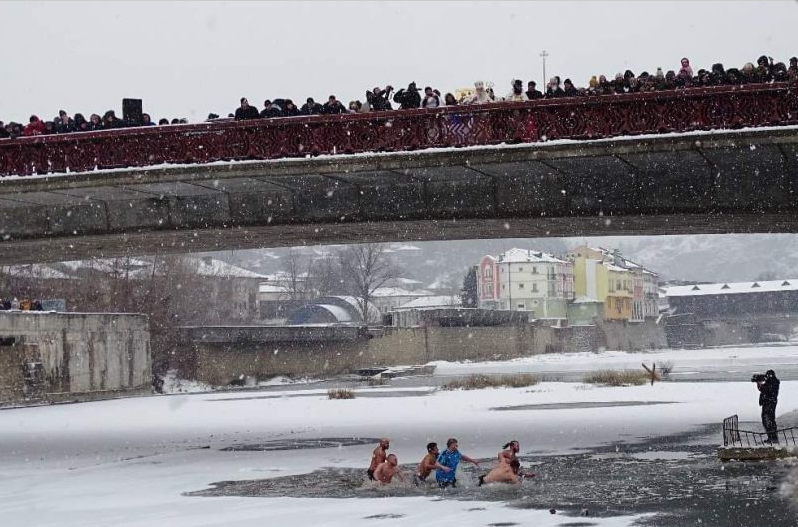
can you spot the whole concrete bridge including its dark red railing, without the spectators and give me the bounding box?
[0,83,798,264]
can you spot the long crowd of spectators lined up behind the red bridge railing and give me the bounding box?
[0,55,798,139]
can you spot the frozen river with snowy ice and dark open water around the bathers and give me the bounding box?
[0,347,798,527]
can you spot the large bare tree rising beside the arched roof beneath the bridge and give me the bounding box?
[338,243,397,323]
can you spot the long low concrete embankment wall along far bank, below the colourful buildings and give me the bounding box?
[183,321,665,385]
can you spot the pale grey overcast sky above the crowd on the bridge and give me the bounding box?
[0,0,798,122]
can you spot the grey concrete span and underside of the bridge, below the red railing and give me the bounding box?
[0,128,798,264]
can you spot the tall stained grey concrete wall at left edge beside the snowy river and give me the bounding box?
[0,311,151,398]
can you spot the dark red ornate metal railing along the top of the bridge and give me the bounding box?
[0,83,798,176]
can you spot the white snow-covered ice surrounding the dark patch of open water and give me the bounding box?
[0,370,798,527]
